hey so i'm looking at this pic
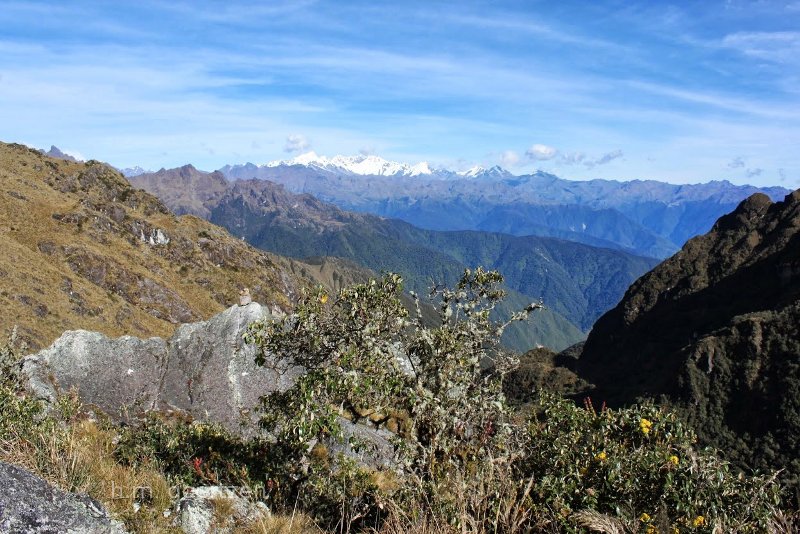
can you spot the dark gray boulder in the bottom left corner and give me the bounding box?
[0,462,127,534]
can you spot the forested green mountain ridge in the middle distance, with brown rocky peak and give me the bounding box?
[132,166,656,350]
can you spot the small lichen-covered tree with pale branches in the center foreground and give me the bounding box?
[246,268,542,528]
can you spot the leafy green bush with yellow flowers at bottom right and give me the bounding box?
[521,395,780,532]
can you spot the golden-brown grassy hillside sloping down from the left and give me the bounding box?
[0,143,330,349]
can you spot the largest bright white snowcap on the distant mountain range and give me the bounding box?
[264,152,433,176]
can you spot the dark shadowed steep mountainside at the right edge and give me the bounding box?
[577,190,800,475]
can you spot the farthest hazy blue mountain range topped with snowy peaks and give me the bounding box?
[220,157,789,258]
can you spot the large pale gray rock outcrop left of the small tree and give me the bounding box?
[23,302,300,431]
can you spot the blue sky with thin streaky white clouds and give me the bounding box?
[0,0,800,188]
